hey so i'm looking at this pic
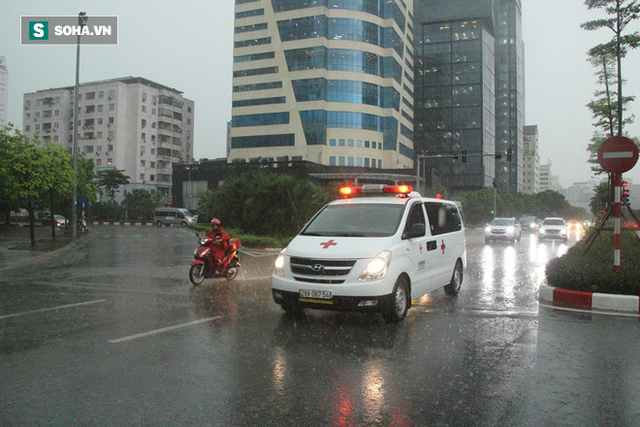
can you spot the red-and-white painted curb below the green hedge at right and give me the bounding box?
[540,280,640,314]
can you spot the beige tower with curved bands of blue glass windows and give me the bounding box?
[229,0,413,169]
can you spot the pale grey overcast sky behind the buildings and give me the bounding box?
[0,0,640,187]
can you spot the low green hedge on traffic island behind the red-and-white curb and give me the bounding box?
[546,232,640,296]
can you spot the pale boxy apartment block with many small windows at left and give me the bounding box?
[23,77,195,200]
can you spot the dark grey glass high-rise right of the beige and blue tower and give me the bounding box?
[414,0,524,192]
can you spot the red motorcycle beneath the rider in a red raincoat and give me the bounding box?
[189,233,242,285]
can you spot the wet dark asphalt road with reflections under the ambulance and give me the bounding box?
[0,226,640,426]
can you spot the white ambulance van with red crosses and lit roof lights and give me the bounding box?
[271,185,467,323]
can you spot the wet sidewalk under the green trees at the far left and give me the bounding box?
[0,223,79,271]
